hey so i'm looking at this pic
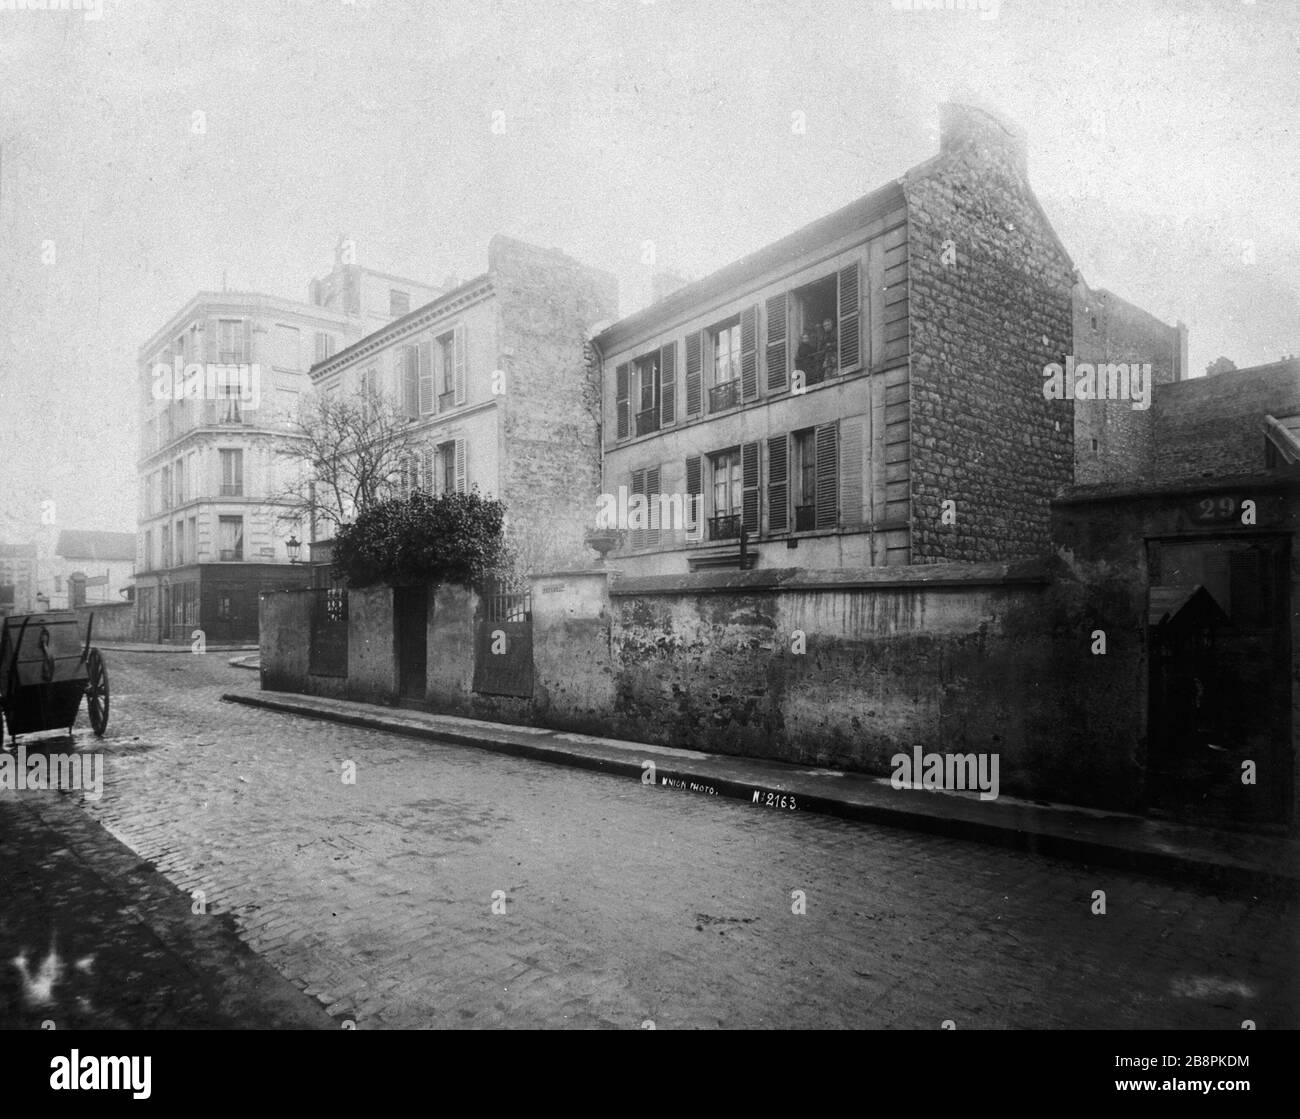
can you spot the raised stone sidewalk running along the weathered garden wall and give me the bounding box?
[222,688,1300,892]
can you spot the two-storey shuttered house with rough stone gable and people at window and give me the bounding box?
[594,104,1186,574]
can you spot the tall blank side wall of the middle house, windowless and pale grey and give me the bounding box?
[490,237,618,571]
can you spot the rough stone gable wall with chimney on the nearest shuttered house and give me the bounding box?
[906,109,1074,563]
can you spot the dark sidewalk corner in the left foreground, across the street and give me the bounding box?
[0,790,338,1029]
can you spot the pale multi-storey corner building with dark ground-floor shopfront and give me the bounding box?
[135,252,429,642]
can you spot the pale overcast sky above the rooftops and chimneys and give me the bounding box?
[0,0,1300,539]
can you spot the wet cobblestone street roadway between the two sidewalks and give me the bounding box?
[0,652,1300,1029]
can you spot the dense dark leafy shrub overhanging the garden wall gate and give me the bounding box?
[334,490,506,587]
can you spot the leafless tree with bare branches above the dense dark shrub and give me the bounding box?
[272,386,416,535]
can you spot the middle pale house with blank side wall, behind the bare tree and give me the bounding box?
[311,235,618,569]
